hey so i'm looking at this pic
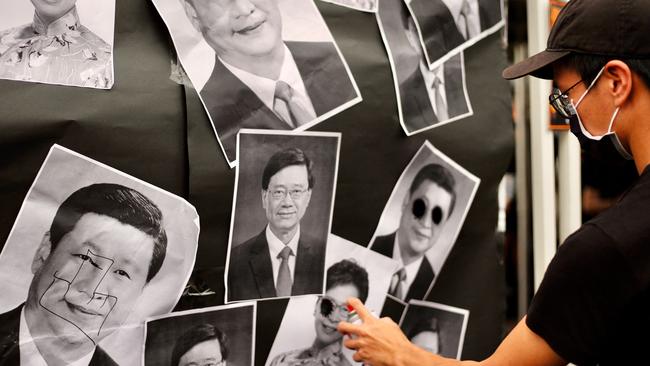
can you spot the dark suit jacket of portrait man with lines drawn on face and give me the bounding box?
[0,305,117,366]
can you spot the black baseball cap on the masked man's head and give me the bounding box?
[502,0,650,79]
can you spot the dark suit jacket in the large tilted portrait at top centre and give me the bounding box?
[200,42,357,161]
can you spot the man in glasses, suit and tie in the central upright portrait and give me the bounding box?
[228,148,325,301]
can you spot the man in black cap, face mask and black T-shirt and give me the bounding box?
[339,0,650,366]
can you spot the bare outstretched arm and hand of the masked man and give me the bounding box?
[338,298,567,366]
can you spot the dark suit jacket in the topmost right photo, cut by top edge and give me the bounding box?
[409,0,501,63]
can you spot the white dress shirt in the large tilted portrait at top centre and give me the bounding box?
[219,45,316,128]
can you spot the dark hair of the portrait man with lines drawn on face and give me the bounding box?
[50,183,167,282]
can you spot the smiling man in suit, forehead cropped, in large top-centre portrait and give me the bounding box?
[180,0,359,162]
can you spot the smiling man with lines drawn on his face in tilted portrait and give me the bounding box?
[0,183,167,365]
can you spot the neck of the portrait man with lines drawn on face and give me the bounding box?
[24,303,95,366]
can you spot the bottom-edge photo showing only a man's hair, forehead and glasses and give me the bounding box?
[143,302,257,366]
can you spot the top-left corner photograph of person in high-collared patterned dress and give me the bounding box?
[0,0,115,89]
